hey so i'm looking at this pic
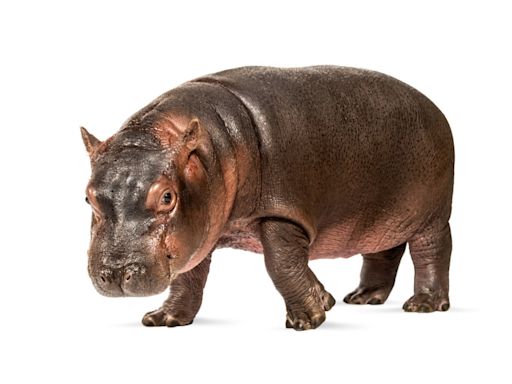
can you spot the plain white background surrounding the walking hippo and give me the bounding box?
[0,0,512,383]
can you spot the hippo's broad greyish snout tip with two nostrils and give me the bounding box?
[91,263,162,297]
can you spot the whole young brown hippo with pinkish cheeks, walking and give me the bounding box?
[81,66,454,330]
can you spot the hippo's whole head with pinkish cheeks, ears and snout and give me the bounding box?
[82,114,229,296]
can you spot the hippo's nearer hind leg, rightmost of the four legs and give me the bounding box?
[403,223,452,312]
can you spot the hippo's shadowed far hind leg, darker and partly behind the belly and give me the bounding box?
[343,243,406,304]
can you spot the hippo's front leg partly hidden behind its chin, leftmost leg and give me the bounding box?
[142,254,211,327]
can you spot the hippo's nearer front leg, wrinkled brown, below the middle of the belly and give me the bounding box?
[261,219,335,330]
